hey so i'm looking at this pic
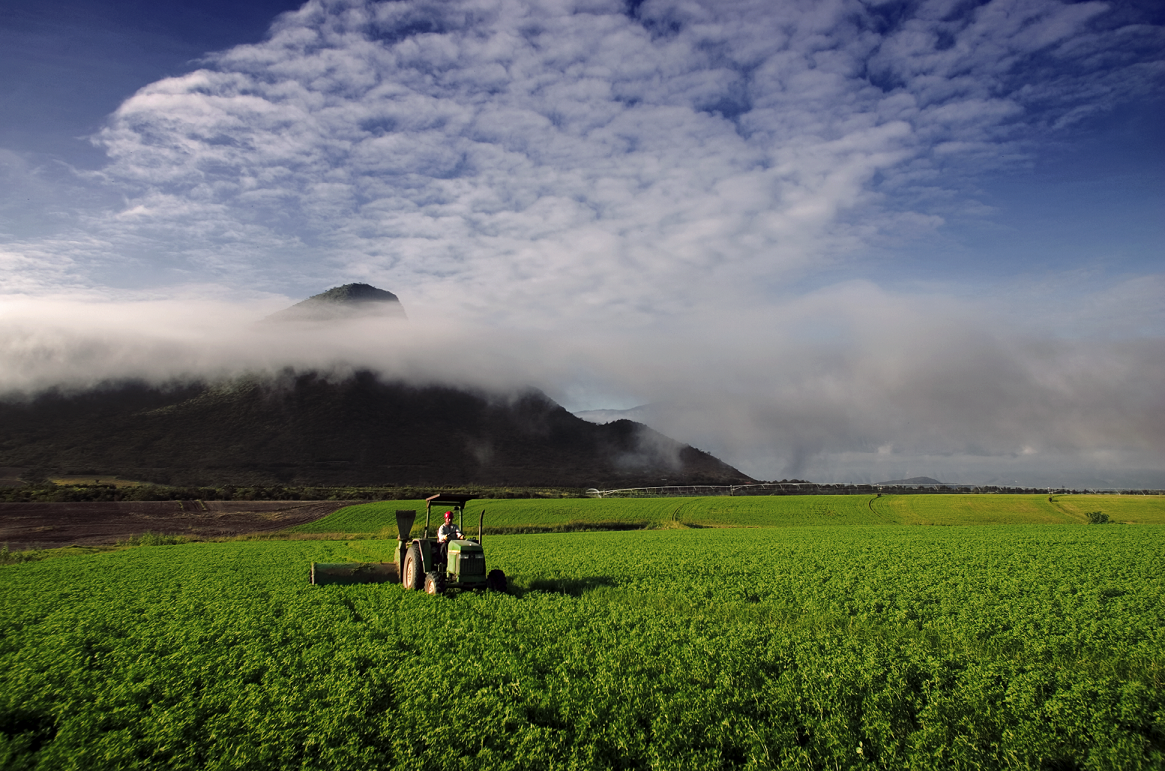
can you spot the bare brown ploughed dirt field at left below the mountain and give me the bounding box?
[0,501,360,551]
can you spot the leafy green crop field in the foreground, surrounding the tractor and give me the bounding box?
[0,526,1165,770]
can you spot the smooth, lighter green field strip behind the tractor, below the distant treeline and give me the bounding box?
[295,495,1165,537]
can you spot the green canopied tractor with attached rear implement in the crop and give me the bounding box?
[311,494,507,594]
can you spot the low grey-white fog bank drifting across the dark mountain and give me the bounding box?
[0,283,1165,487]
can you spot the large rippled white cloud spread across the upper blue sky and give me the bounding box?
[0,0,1149,325]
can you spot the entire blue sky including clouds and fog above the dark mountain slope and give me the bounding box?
[0,0,1165,487]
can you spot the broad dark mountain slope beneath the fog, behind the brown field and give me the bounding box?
[0,372,751,487]
